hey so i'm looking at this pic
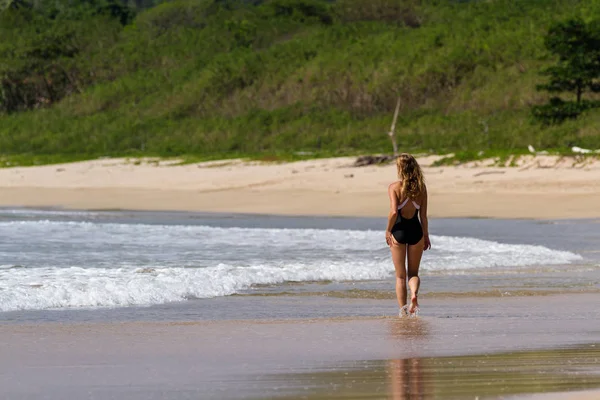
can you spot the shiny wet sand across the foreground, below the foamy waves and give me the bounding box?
[0,294,600,399]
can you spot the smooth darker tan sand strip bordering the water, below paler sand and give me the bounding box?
[0,187,600,220]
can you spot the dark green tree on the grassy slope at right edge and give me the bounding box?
[532,19,600,124]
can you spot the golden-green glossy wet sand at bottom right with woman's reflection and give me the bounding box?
[272,346,600,400]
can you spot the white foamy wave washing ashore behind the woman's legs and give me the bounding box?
[0,221,581,311]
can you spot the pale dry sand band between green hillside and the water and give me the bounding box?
[0,156,600,219]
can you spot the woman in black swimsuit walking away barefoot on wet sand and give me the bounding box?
[385,153,431,317]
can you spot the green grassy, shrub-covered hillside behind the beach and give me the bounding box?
[0,0,600,164]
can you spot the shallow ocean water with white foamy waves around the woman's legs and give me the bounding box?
[0,209,600,319]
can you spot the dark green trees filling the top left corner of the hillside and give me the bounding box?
[0,0,125,113]
